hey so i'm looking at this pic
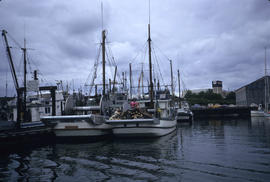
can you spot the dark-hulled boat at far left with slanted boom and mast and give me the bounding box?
[0,30,56,143]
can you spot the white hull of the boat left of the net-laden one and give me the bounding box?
[53,120,112,137]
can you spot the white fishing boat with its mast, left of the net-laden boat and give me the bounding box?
[41,30,115,139]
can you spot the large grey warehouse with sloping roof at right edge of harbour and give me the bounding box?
[235,76,270,107]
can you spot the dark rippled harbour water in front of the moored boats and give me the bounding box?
[0,118,270,182]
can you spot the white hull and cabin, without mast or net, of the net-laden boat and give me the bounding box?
[106,100,177,138]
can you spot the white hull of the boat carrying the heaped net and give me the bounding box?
[112,120,177,137]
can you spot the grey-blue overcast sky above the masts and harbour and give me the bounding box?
[0,0,270,96]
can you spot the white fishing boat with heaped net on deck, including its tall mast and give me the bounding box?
[106,18,177,138]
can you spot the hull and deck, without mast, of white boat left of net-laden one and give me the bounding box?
[41,97,112,139]
